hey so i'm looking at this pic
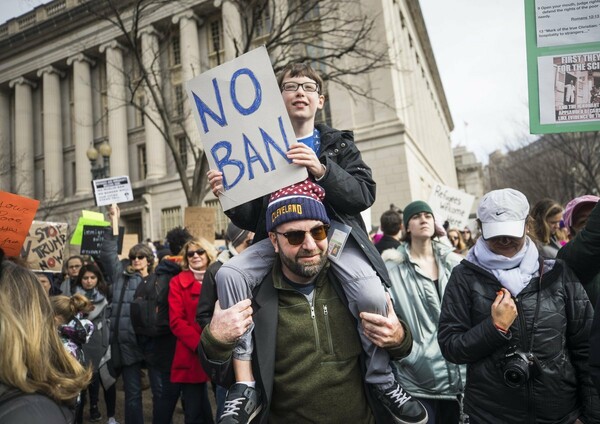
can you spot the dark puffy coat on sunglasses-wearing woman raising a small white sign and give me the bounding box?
[100,229,144,365]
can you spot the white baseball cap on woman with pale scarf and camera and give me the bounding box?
[477,188,529,240]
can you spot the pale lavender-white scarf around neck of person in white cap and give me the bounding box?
[467,237,539,296]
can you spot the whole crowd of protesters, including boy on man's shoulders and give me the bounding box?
[0,58,600,424]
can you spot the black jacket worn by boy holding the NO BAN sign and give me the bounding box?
[225,125,390,287]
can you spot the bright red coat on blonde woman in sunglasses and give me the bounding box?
[169,271,208,383]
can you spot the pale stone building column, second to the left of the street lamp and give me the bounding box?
[38,66,64,200]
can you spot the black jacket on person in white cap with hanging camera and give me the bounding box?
[438,260,600,424]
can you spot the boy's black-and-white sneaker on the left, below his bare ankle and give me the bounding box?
[218,383,262,424]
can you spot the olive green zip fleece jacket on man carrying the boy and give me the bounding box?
[202,261,412,424]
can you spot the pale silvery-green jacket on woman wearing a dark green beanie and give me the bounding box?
[382,241,466,399]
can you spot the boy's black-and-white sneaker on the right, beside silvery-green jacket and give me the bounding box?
[373,382,427,424]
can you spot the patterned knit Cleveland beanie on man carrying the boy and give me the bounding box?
[266,180,329,231]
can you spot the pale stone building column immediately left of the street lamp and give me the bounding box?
[67,53,94,196]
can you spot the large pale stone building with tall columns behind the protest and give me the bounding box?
[0,0,457,240]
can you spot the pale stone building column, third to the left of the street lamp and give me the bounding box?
[8,77,35,197]
